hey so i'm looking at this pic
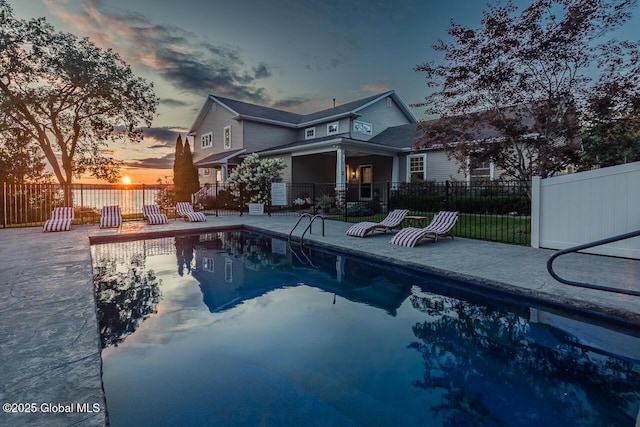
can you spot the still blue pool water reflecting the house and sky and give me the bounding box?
[92,231,640,427]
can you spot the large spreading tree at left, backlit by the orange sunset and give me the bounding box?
[0,0,158,202]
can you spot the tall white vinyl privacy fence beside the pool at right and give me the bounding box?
[531,162,640,259]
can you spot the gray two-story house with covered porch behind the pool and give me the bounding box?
[189,91,476,200]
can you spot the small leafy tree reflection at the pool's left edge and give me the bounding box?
[93,255,161,348]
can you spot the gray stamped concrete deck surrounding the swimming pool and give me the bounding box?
[0,216,640,426]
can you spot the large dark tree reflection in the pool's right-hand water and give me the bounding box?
[409,294,640,426]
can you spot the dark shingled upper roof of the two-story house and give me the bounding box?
[189,90,416,134]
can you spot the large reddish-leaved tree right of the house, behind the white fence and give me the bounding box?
[416,0,637,194]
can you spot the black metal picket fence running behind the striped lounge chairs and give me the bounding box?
[0,182,531,245]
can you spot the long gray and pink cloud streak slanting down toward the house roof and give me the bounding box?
[45,0,272,104]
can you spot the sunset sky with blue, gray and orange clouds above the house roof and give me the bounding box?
[9,0,640,183]
